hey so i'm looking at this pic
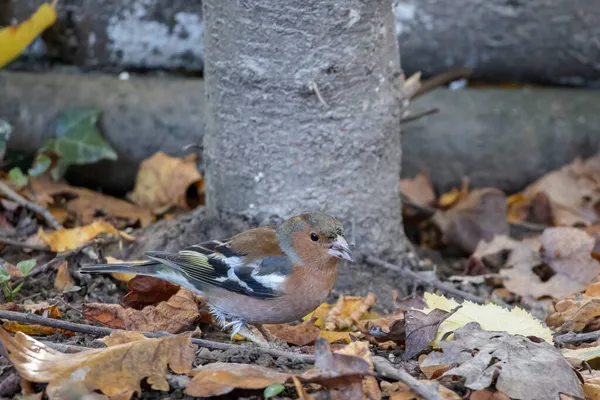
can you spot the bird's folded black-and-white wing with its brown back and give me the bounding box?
[141,228,293,298]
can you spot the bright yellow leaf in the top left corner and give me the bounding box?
[0,4,56,68]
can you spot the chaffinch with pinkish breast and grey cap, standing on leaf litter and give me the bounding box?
[80,212,353,347]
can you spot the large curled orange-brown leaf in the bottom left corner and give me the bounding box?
[0,330,196,399]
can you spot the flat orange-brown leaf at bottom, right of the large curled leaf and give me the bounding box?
[185,362,292,397]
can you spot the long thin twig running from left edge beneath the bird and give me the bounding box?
[0,311,315,363]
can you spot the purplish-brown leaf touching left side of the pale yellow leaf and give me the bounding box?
[402,309,455,361]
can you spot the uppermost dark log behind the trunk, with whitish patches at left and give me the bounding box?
[7,0,600,85]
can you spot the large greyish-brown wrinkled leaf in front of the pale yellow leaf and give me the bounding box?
[422,323,584,399]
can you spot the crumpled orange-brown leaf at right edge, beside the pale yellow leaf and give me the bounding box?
[546,294,600,332]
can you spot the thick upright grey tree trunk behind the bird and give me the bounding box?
[203,0,404,256]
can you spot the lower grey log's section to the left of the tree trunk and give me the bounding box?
[0,72,204,191]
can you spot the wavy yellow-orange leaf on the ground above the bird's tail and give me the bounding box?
[38,221,135,252]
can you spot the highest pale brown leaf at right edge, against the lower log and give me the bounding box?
[523,153,600,226]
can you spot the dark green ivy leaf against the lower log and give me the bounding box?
[42,107,117,178]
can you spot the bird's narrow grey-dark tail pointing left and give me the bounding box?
[79,261,201,291]
